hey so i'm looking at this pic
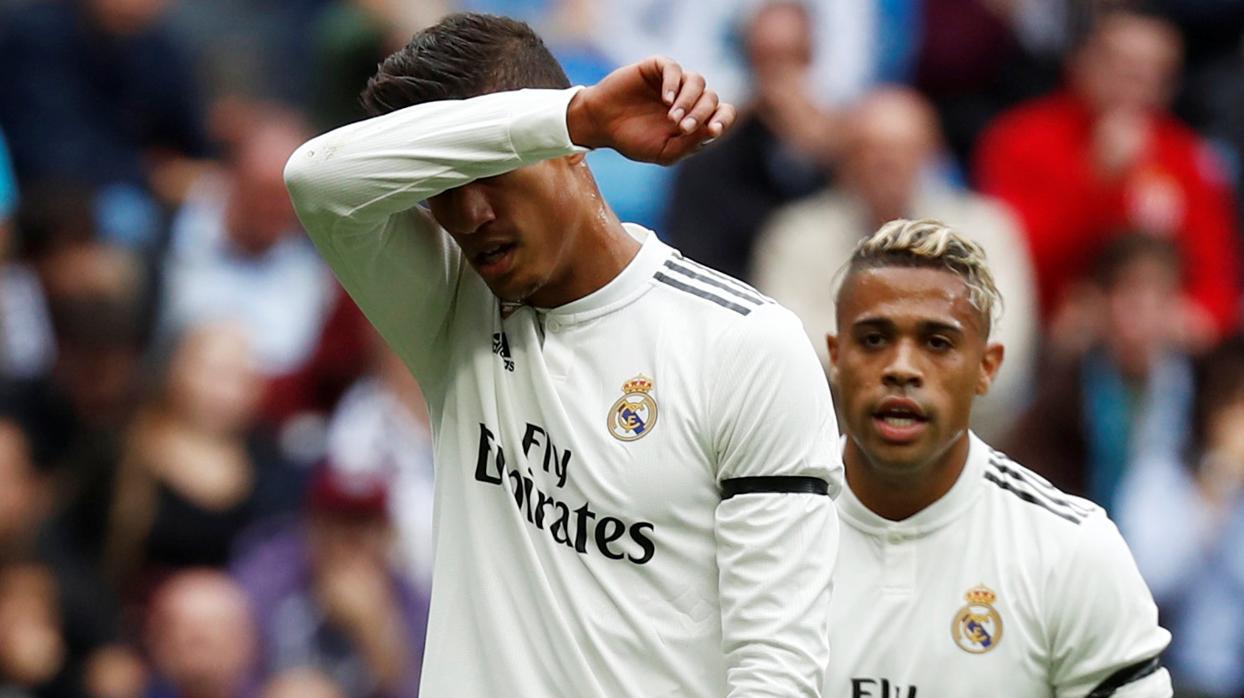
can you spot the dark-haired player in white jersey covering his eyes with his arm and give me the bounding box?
[286,14,841,698]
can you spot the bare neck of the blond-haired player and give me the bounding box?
[842,432,969,521]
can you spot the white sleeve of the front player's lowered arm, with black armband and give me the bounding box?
[708,306,842,698]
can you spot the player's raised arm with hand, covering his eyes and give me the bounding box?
[285,58,734,391]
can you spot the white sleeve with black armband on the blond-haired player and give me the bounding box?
[1045,510,1172,698]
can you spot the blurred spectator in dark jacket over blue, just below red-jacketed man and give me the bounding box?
[1005,234,1193,511]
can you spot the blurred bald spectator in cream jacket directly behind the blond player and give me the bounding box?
[753,88,1036,439]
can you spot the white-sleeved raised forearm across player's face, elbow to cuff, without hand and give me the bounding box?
[285,90,581,235]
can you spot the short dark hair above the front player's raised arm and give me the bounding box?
[361,12,570,116]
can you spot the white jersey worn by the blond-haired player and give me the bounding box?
[825,435,1171,698]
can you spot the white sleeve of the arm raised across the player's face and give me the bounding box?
[285,88,583,389]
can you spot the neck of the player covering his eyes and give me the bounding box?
[527,187,641,307]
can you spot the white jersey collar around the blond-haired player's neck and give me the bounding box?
[838,432,989,539]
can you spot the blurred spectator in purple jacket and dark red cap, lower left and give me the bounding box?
[233,468,427,698]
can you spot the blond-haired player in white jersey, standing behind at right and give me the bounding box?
[825,220,1171,698]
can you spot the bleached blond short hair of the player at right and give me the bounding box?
[840,218,1003,337]
